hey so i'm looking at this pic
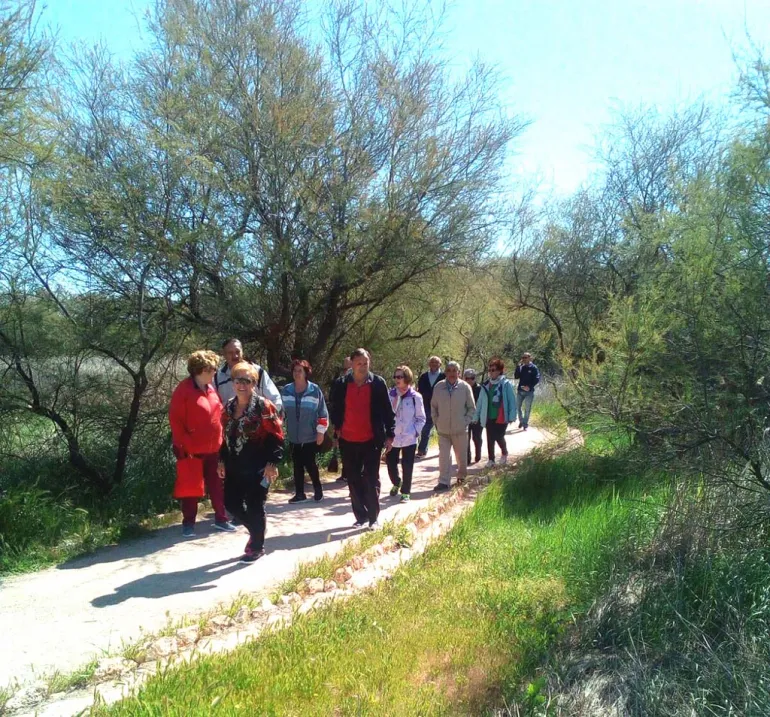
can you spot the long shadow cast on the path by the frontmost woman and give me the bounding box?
[91,558,248,607]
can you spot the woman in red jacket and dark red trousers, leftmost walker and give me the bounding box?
[168,351,235,538]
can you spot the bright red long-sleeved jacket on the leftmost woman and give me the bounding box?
[168,378,222,458]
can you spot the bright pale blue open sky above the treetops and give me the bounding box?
[43,0,770,194]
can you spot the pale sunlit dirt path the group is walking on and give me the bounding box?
[0,428,551,687]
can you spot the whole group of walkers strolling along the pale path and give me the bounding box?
[169,339,540,562]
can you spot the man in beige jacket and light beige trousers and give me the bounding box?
[430,361,476,493]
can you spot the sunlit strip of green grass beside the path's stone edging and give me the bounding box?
[95,440,665,715]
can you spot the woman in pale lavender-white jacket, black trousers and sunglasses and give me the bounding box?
[385,366,426,503]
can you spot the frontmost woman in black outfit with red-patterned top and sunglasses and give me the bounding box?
[219,362,283,563]
